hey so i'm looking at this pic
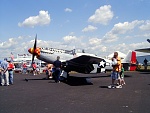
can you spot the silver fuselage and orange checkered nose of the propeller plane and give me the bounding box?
[28,47,99,63]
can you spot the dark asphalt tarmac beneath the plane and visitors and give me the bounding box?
[0,72,150,113]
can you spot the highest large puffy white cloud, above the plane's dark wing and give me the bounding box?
[88,5,114,25]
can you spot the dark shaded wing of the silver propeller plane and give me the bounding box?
[64,55,105,73]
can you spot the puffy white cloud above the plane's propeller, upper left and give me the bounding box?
[18,10,51,28]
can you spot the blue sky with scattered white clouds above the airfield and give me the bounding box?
[0,0,150,59]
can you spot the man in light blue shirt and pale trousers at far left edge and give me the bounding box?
[0,58,9,86]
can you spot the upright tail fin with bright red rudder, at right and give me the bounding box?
[122,51,136,71]
